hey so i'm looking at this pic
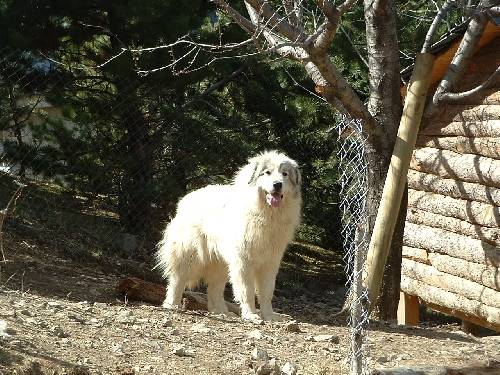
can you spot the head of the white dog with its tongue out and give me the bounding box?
[234,151,302,208]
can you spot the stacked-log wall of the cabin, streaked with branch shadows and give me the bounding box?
[400,33,500,331]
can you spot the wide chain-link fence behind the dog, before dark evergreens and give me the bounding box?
[0,49,342,274]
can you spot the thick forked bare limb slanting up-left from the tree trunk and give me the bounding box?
[213,0,378,141]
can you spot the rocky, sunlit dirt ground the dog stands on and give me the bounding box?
[0,233,500,375]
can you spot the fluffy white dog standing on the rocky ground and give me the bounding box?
[157,151,301,320]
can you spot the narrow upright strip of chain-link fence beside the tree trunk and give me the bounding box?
[336,119,371,375]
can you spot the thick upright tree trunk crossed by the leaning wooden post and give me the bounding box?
[364,0,406,320]
